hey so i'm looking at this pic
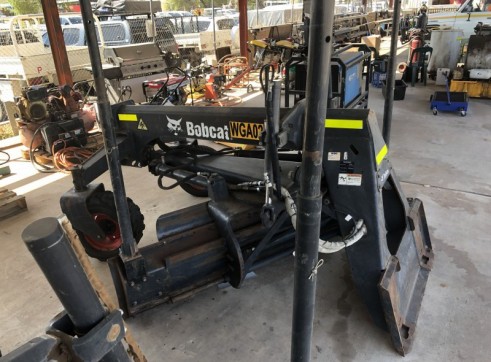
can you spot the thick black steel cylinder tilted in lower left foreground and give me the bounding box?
[22,217,130,361]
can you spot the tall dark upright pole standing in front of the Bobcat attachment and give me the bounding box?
[291,0,334,362]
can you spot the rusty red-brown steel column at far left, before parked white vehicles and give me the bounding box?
[41,0,73,86]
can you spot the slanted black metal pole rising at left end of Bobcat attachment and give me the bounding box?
[80,0,137,257]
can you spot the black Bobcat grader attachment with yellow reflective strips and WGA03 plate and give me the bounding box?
[61,2,433,355]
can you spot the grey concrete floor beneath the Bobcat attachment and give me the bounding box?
[0,58,491,362]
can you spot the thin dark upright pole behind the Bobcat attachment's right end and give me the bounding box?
[382,0,401,146]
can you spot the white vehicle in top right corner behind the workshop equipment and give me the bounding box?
[427,0,491,39]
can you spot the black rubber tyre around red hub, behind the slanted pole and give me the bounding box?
[75,191,145,261]
